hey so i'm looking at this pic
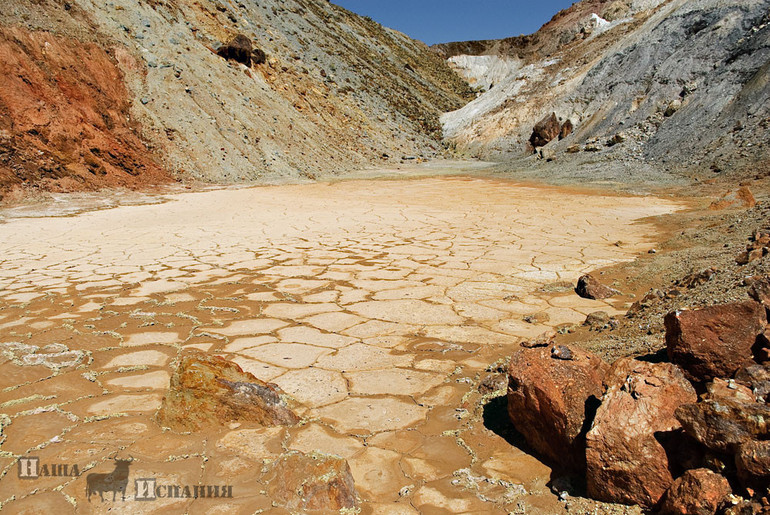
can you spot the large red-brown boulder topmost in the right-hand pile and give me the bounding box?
[664,300,767,381]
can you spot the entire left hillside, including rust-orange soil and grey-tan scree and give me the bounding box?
[0,0,472,200]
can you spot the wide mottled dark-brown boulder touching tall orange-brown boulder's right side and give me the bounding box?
[676,399,770,454]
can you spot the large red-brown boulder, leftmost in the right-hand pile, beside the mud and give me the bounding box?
[508,345,609,469]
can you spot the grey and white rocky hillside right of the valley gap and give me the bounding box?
[434,0,770,179]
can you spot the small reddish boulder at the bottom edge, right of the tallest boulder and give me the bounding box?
[660,468,732,515]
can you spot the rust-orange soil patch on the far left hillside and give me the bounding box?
[0,27,171,200]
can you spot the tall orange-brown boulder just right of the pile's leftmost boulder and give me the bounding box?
[586,358,697,508]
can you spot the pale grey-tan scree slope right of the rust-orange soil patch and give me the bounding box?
[0,0,471,187]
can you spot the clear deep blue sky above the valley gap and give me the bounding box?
[332,0,574,45]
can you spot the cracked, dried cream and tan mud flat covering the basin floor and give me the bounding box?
[0,177,682,513]
